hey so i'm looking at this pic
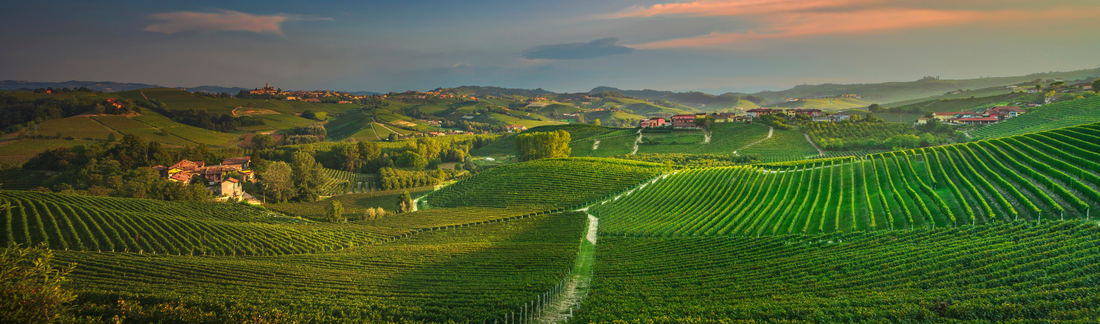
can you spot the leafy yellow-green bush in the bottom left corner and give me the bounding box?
[0,244,76,323]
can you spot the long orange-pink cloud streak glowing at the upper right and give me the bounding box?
[604,0,1100,49]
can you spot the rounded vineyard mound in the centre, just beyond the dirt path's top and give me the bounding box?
[424,158,668,209]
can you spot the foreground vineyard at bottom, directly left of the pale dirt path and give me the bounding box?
[57,213,586,323]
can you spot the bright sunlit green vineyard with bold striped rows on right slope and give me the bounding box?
[592,124,1100,236]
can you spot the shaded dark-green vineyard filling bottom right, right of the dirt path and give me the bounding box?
[575,220,1100,323]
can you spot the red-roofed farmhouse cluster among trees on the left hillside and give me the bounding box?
[153,156,255,198]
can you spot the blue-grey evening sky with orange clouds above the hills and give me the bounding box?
[0,0,1100,94]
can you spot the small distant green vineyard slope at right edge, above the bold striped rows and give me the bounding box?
[970,97,1100,139]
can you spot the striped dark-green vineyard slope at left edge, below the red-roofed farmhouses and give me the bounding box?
[0,191,550,256]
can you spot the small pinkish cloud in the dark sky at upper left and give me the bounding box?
[144,10,332,35]
